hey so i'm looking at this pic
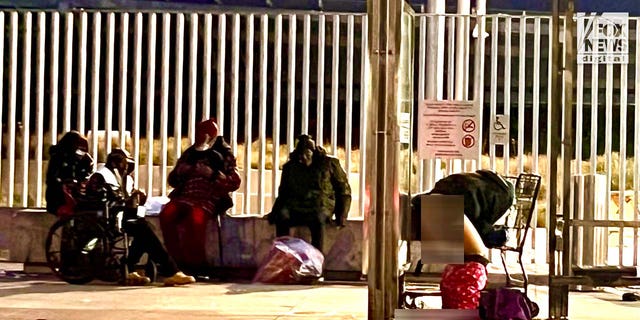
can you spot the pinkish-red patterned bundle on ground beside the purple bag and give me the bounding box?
[440,262,487,309]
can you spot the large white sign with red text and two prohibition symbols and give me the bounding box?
[418,100,481,160]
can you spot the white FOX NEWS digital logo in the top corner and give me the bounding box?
[577,12,629,64]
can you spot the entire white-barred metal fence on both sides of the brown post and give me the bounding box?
[0,11,640,265]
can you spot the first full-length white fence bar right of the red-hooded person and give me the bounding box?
[243,14,254,214]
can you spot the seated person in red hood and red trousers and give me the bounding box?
[160,119,240,275]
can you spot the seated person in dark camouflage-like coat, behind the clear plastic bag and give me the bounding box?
[267,135,351,251]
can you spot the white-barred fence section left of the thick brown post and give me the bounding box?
[0,11,366,217]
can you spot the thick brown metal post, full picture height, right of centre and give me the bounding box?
[365,0,404,320]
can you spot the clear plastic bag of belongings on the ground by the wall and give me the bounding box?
[253,237,324,284]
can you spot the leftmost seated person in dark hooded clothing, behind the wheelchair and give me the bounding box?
[45,131,93,217]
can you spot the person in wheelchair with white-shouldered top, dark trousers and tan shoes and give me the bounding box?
[86,149,195,286]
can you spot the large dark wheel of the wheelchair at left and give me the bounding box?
[45,214,110,284]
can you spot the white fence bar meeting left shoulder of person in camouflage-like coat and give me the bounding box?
[287,14,297,152]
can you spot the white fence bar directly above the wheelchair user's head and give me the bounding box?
[118,12,129,149]
